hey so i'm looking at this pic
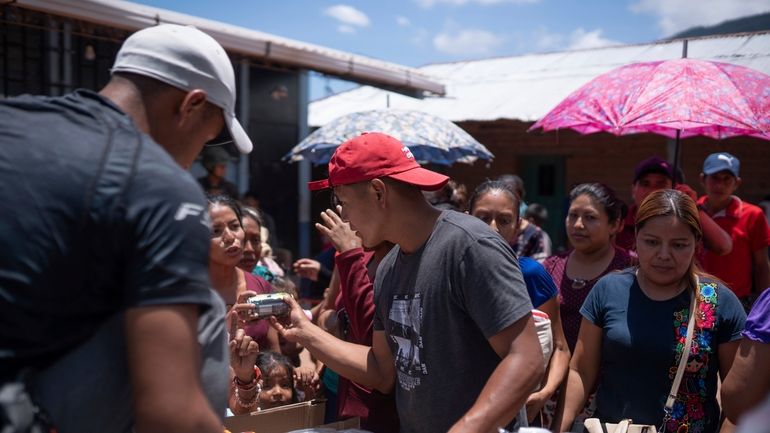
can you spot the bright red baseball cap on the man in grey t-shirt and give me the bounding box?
[308,132,449,191]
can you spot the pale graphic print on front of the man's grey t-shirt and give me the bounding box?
[388,293,428,390]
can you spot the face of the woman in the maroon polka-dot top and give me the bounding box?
[566,194,620,253]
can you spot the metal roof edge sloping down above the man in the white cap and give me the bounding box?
[11,0,444,94]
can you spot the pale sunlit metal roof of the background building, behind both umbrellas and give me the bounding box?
[308,33,770,126]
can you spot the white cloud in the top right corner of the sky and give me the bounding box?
[631,0,770,36]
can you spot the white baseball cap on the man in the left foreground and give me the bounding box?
[112,24,252,153]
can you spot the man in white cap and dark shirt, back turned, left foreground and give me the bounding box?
[0,25,252,433]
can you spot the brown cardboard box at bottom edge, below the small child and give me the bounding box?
[224,400,326,433]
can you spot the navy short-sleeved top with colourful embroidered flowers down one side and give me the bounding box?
[580,269,746,432]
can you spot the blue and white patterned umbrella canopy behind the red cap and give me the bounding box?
[284,108,494,165]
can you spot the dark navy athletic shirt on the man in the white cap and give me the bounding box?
[0,90,210,374]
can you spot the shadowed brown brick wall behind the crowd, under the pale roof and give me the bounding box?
[446,120,770,204]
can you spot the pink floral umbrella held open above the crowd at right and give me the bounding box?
[529,58,770,172]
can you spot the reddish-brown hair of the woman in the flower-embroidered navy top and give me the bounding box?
[634,189,703,289]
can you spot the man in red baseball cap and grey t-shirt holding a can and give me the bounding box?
[272,133,543,433]
